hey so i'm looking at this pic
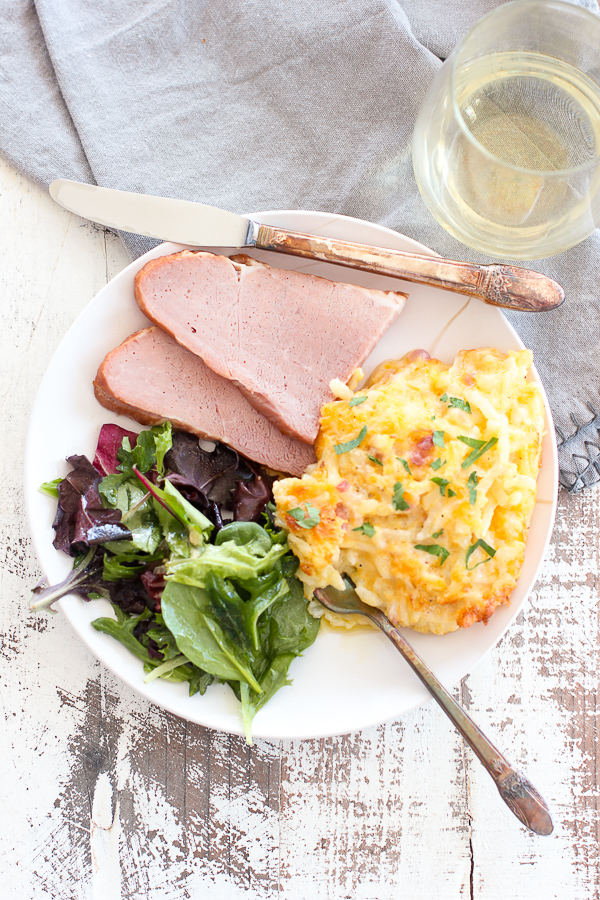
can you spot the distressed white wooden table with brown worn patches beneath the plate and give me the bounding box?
[0,164,600,900]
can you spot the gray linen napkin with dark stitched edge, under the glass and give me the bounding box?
[0,0,600,491]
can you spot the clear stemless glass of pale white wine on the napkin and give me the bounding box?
[413,0,600,260]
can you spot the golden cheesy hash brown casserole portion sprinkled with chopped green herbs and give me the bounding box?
[274,349,544,634]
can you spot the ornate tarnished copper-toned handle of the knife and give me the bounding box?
[256,225,565,312]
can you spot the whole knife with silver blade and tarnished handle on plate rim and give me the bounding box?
[50,178,565,312]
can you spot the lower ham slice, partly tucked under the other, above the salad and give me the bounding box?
[94,327,315,475]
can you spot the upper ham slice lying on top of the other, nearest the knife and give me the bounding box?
[135,250,406,444]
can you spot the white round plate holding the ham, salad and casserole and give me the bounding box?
[25,211,558,738]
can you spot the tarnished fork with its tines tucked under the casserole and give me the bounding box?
[314,585,554,835]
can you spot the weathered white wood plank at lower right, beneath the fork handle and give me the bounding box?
[469,491,600,900]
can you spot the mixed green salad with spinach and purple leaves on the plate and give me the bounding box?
[31,423,319,742]
